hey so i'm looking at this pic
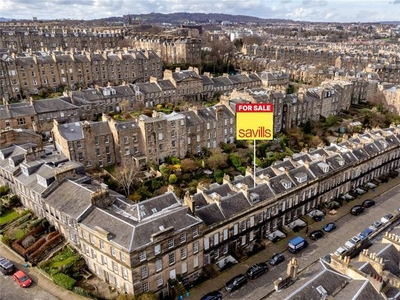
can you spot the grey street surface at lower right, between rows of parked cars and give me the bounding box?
[220,186,400,300]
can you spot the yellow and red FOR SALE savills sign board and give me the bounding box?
[236,103,274,140]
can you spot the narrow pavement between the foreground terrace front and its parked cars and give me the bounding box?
[184,176,400,300]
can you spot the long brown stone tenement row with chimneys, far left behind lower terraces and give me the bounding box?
[0,49,162,99]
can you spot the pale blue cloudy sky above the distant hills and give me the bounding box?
[0,0,400,22]
